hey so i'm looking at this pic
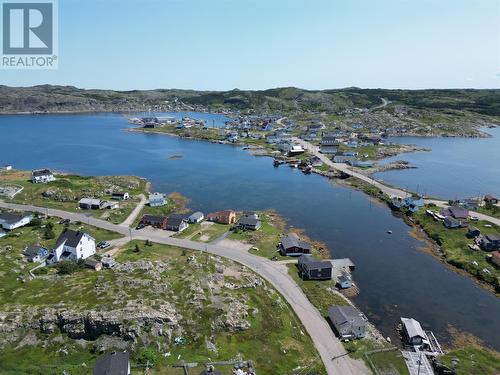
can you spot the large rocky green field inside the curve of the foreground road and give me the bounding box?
[0,225,325,374]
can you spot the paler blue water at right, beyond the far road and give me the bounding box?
[375,128,500,199]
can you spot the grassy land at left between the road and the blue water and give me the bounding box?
[0,171,146,224]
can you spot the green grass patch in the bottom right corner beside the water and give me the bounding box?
[439,346,500,375]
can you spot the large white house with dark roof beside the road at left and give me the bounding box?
[47,229,95,264]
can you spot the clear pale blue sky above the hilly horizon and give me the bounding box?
[0,0,500,90]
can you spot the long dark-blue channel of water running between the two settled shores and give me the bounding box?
[0,114,500,349]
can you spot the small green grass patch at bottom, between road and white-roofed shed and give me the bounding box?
[344,340,410,375]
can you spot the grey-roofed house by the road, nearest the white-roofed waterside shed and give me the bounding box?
[328,306,367,340]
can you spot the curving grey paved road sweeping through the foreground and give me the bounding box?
[0,201,371,375]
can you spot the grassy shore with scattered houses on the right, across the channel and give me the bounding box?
[413,207,500,292]
